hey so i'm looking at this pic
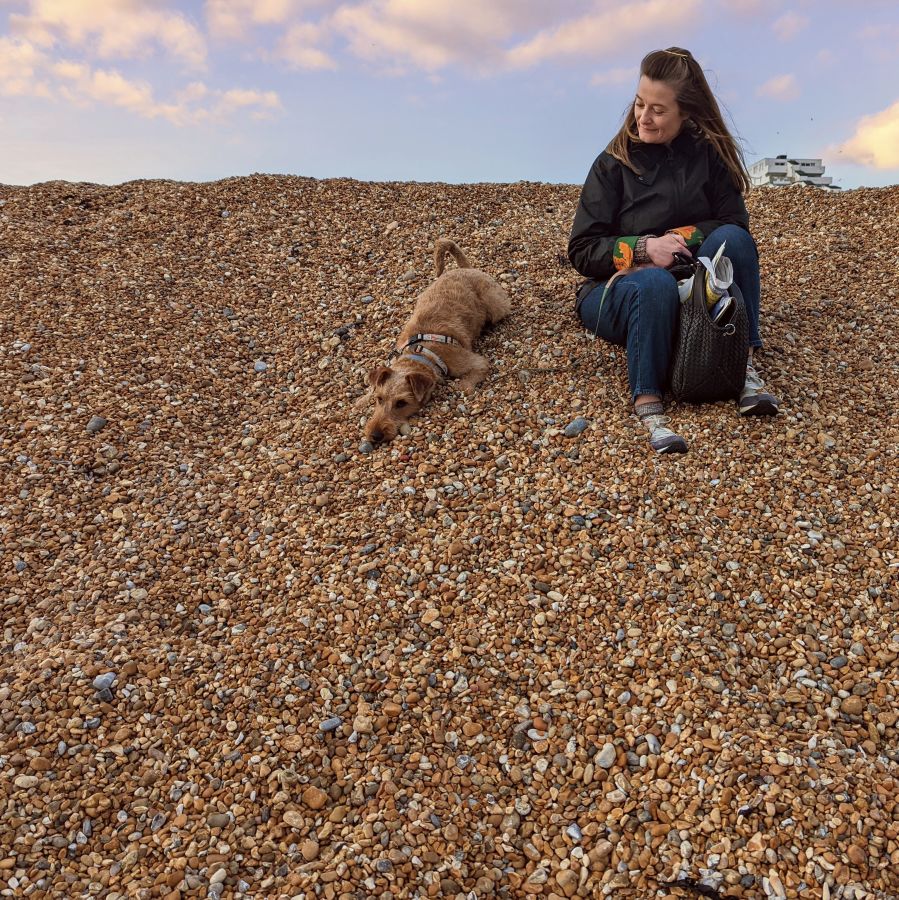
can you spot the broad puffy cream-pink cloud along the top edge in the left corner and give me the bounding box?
[9,0,206,69]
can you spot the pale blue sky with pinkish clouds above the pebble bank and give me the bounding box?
[0,0,899,188]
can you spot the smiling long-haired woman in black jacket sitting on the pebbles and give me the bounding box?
[568,47,778,453]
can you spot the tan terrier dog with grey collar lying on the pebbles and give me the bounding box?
[365,238,512,443]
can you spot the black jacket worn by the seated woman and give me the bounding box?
[568,128,749,281]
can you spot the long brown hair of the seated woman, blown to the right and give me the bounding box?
[606,47,752,193]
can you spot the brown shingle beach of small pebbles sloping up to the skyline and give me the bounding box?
[0,176,899,900]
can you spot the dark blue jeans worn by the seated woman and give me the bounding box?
[579,225,762,399]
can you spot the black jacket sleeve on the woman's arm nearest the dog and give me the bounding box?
[568,156,622,279]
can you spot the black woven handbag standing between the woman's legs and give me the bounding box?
[671,263,749,403]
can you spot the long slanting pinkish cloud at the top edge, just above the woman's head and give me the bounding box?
[508,0,700,67]
